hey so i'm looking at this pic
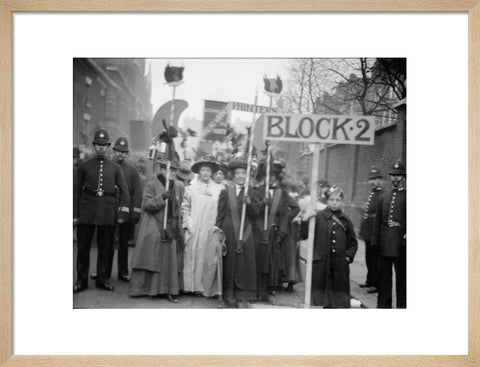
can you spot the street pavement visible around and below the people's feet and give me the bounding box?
[72,240,377,309]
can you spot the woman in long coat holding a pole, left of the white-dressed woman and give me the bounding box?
[129,161,183,303]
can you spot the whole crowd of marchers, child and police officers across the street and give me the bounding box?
[73,129,406,308]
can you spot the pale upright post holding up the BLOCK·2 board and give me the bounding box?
[305,144,320,308]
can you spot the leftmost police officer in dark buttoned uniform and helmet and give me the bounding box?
[73,129,129,293]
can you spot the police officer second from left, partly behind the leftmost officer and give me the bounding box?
[110,137,142,282]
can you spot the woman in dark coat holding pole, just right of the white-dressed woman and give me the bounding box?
[215,158,263,308]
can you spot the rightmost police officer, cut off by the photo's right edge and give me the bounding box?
[372,160,407,308]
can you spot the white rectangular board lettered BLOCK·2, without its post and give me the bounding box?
[263,113,375,145]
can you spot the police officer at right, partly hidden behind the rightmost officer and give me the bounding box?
[360,166,385,293]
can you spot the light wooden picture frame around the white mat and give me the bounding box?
[0,0,480,367]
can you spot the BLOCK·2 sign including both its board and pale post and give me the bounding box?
[263,112,375,308]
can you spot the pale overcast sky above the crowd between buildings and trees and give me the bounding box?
[149,59,289,129]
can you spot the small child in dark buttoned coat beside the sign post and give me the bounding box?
[301,186,357,308]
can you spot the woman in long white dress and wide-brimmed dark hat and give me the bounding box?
[182,156,223,297]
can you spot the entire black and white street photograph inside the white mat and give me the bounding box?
[72,57,406,309]
